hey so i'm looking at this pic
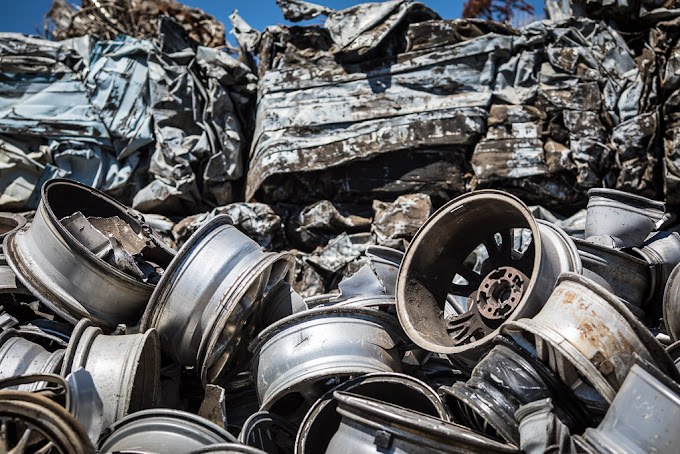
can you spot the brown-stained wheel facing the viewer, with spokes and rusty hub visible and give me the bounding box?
[397,190,581,367]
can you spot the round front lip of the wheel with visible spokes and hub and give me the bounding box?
[395,189,543,354]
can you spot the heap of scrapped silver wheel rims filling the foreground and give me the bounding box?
[0,179,680,454]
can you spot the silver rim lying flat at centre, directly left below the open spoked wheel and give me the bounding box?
[250,307,405,423]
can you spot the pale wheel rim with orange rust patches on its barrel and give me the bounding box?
[503,273,678,403]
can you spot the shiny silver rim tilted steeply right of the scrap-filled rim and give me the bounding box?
[140,215,293,383]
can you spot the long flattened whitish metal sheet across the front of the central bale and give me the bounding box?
[246,35,512,199]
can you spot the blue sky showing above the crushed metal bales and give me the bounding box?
[0,0,543,42]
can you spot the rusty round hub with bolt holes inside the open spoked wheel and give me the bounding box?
[477,266,529,320]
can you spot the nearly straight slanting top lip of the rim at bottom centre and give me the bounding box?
[333,391,517,452]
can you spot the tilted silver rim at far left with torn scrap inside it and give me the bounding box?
[4,179,174,329]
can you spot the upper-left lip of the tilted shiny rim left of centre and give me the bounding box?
[139,214,236,331]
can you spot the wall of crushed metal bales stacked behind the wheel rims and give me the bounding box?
[0,0,680,296]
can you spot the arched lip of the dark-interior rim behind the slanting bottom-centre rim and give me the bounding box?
[295,372,449,454]
